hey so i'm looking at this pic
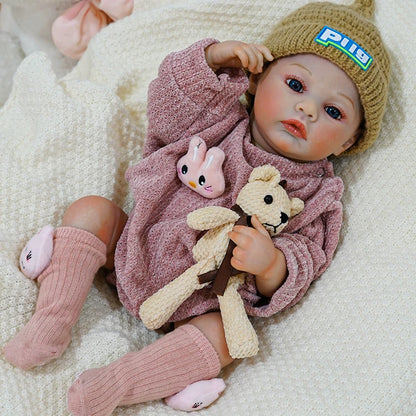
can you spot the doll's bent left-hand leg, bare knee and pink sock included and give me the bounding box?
[3,197,126,370]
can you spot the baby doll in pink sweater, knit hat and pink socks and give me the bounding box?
[4,0,390,416]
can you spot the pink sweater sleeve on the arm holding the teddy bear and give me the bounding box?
[242,178,343,317]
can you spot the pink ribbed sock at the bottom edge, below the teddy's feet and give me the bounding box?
[68,324,221,416]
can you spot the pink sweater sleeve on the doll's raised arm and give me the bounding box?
[144,39,248,156]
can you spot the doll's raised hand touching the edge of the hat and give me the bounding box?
[205,40,273,74]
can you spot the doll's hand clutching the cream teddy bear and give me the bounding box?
[229,215,287,297]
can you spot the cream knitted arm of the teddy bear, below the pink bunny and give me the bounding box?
[187,206,239,231]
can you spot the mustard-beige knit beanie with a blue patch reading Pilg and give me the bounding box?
[264,0,390,155]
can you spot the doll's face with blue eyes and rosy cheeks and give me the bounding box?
[250,54,362,161]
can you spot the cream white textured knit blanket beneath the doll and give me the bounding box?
[0,0,416,416]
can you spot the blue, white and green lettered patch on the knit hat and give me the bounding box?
[315,26,373,71]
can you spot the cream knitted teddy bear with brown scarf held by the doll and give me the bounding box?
[140,165,304,358]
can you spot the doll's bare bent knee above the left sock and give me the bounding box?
[62,195,127,249]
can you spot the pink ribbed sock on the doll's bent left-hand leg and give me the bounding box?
[3,227,106,370]
